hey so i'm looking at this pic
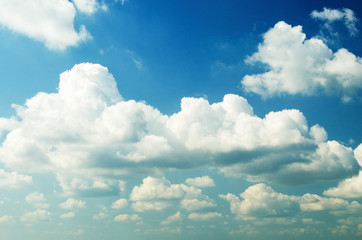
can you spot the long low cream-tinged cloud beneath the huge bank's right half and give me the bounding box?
[219,183,362,220]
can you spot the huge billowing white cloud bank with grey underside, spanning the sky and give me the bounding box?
[0,63,360,193]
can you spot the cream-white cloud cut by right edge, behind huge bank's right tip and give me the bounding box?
[323,144,362,198]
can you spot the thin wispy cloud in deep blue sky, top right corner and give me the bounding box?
[310,7,358,36]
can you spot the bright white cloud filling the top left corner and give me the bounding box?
[0,0,91,50]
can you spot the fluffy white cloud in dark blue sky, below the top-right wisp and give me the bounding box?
[241,22,362,102]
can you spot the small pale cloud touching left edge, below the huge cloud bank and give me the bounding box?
[0,169,33,189]
